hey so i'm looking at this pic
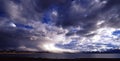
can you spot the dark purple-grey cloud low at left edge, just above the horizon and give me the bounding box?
[0,28,37,50]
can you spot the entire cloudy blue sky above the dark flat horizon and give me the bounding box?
[0,0,120,53]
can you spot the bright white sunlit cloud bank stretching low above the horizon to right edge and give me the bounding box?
[27,19,120,53]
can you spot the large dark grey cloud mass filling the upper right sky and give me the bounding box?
[57,0,120,35]
